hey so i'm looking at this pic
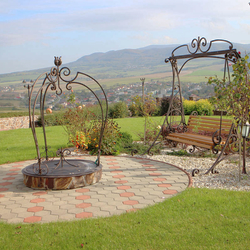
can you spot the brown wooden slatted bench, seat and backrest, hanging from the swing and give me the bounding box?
[166,116,232,149]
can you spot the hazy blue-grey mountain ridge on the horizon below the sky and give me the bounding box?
[0,43,250,84]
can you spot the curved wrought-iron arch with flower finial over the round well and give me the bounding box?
[27,57,108,175]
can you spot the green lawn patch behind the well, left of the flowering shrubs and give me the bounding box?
[0,126,68,164]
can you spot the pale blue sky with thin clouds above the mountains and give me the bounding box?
[0,0,250,74]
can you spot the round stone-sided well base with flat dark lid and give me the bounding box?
[22,159,102,190]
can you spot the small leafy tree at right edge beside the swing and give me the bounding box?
[208,55,250,173]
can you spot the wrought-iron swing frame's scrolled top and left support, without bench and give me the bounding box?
[145,37,240,158]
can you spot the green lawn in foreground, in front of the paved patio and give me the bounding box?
[0,188,250,250]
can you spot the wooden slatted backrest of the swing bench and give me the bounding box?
[188,115,232,134]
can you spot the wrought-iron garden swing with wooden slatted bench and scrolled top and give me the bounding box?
[145,37,240,174]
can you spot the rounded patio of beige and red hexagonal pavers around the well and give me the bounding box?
[0,156,192,223]
